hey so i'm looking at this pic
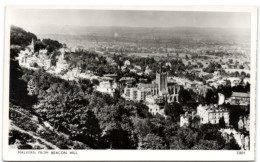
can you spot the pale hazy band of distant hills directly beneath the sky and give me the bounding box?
[11,24,250,35]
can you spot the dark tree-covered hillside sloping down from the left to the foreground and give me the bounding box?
[9,27,242,150]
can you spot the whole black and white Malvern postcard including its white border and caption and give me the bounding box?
[3,6,257,160]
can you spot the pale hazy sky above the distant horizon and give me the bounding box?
[11,9,250,28]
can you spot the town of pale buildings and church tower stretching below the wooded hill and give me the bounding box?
[11,25,250,150]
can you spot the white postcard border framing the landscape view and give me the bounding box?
[3,6,257,161]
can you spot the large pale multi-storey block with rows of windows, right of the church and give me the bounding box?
[197,105,229,126]
